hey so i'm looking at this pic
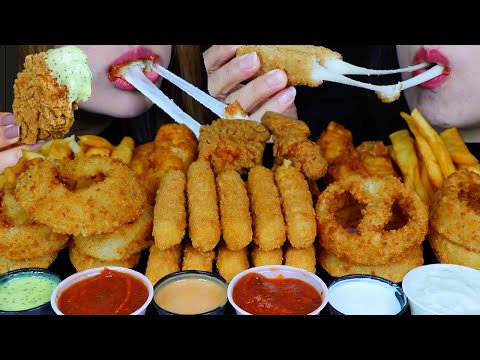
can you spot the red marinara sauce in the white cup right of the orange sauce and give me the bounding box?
[232,273,322,315]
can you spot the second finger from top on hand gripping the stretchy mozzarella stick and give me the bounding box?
[208,52,260,101]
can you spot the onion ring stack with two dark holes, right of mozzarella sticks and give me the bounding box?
[316,175,428,281]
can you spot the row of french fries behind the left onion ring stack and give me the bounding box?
[0,135,135,188]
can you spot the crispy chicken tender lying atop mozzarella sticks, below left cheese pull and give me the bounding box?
[198,119,270,175]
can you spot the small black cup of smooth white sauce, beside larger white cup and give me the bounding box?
[328,274,408,315]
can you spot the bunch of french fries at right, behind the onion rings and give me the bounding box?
[389,109,480,205]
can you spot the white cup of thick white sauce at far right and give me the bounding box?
[407,267,480,315]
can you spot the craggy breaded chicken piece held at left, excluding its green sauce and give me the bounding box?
[12,53,77,144]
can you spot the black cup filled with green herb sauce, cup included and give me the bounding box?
[0,268,62,315]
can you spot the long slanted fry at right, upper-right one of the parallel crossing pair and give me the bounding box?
[411,108,457,179]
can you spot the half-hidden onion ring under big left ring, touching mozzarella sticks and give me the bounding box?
[73,205,153,261]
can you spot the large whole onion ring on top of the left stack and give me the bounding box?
[15,155,147,236]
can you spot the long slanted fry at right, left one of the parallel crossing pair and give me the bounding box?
[400,112,445,189]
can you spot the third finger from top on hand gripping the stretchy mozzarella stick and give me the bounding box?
[225,69,288,113]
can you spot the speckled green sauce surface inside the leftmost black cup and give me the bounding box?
[0,273,59,311]
